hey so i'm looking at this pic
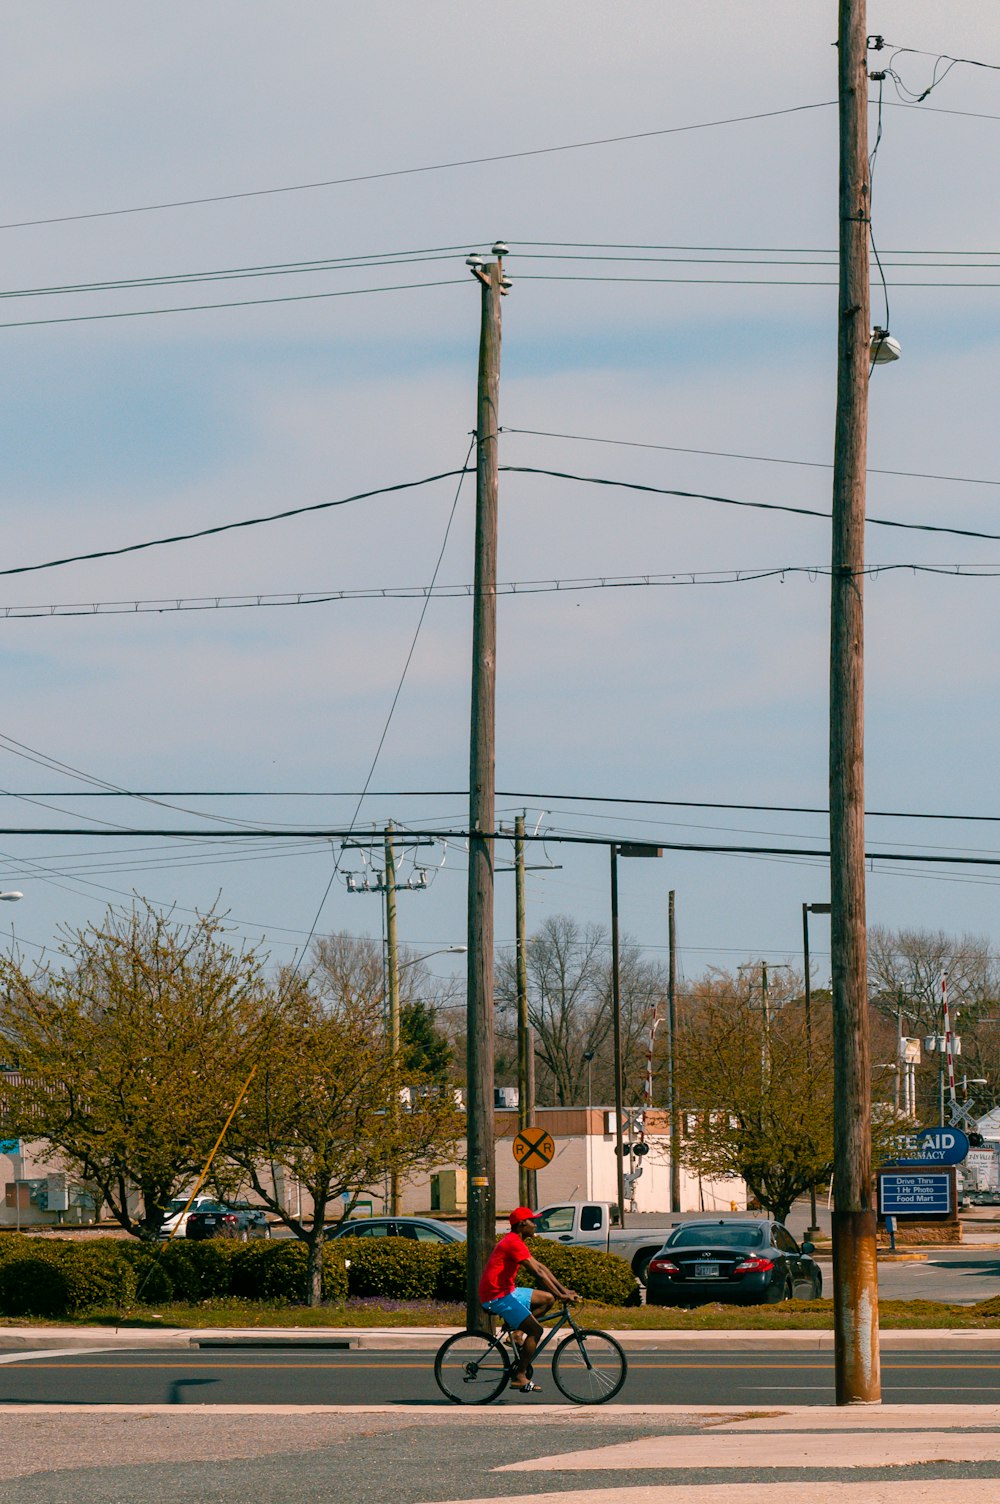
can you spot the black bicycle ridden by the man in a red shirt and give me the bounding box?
[435,1301,629,1405]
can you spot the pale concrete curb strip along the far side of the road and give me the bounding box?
[0,1327,1000,1354]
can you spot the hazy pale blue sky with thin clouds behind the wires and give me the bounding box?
[0,0,1000,1004]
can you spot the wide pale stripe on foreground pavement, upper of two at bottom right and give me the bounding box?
[496,1430,1000,1467]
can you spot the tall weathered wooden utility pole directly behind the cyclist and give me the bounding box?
[466,247,505,1331]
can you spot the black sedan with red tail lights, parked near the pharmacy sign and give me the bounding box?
[647,1217,823,1305]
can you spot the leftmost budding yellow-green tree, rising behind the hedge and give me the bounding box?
[0,904,268,1238]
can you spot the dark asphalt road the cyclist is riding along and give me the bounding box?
[0,1342,1000,1408]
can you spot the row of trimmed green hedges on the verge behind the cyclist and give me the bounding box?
[0,1233,636,1316]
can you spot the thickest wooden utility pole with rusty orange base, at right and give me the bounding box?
[830,0,881,1405]
